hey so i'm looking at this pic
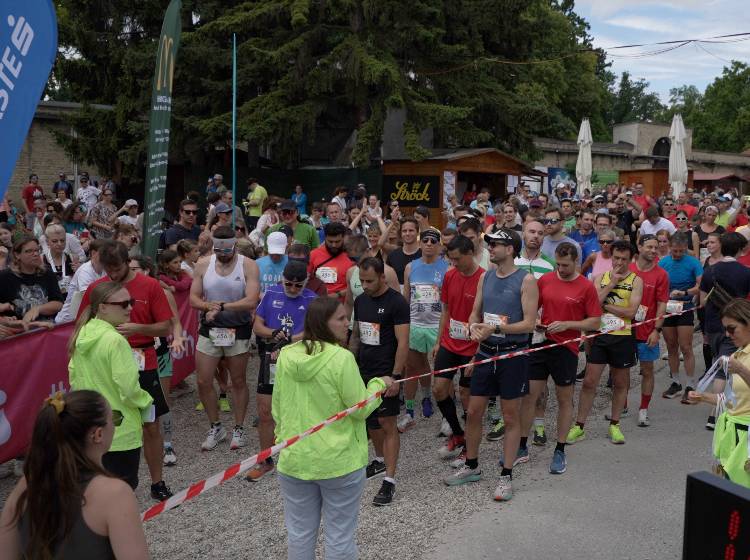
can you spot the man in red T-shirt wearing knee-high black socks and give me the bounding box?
[432,235,484,466]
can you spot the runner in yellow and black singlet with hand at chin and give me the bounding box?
[567,241,643,444]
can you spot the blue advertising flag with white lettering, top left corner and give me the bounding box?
[0,0,57,202]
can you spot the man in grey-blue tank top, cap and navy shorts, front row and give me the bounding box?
[445,228,539,501]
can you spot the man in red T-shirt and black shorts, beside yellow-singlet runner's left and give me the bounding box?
[519,242,602,474]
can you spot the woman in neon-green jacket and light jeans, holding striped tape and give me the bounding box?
[271,298,393,560]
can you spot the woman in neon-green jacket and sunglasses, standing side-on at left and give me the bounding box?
[68,282,153,490]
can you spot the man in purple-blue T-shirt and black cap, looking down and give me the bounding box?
[245,261,317,482]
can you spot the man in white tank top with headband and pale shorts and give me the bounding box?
[190,226,260,451]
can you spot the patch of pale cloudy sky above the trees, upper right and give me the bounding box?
[576,0,750,103]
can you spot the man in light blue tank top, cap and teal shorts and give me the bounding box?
[398,228,448,432]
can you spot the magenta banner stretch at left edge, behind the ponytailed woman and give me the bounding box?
[0,323,73,463]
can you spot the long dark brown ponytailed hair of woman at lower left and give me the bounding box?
[12,391,109,559]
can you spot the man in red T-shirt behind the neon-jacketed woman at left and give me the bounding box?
[78,239,172,501]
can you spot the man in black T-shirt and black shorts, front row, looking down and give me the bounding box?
[350,257,410,506]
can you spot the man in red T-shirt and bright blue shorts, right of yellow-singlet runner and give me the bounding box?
[629,235,669,428]
